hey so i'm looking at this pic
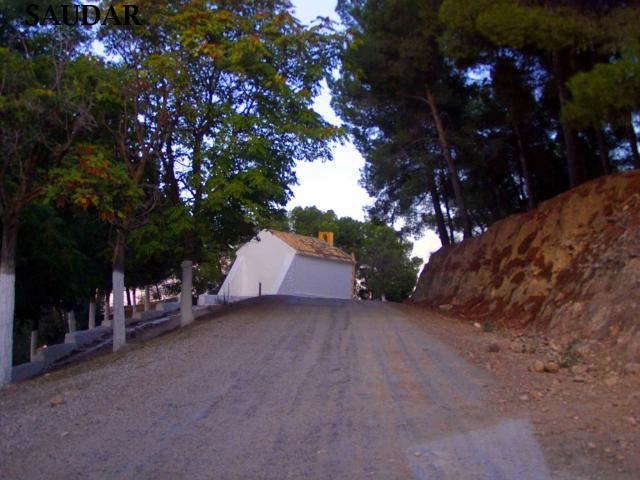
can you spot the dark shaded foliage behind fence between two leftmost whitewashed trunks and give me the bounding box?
[14,204,111,363]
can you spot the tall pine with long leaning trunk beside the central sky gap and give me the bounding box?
[334,0,472,237]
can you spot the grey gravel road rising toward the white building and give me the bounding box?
[0,297,550,480]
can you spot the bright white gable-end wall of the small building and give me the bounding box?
[218,231,295,297]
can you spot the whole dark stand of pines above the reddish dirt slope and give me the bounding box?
[332,0,640,245]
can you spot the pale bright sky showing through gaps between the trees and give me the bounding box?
[287,0,441,261]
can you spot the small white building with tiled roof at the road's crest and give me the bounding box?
[198,230,354,304]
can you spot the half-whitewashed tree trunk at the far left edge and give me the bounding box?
[0,215,18,387]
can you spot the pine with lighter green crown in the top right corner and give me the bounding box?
[440,0,637,187]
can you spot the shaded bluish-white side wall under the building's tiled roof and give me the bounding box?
[278,255,353,299]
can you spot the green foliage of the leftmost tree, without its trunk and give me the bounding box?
[0,47,97,210]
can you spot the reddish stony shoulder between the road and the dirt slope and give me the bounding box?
[403,307,640,479]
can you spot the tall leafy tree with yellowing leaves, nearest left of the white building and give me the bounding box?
[104,0,338,324]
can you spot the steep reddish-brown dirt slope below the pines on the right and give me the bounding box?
[413,171,640,359]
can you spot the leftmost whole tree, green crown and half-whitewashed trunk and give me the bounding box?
[0,2,93,385]
